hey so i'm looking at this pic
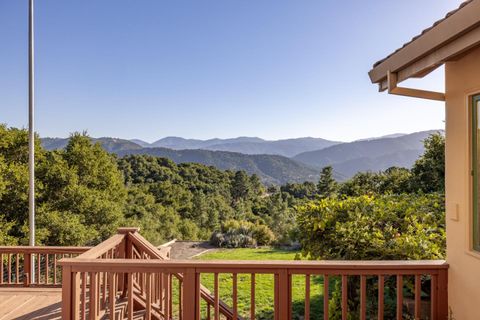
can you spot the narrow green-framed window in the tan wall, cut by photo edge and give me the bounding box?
[471,94,480,251]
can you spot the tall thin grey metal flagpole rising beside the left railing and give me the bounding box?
[28,0,35,282]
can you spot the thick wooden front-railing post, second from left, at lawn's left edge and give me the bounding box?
[182,268,200,320]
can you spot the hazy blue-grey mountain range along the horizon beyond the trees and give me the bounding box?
[42,130,443,184]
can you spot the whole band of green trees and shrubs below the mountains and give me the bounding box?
[0,126,444,258]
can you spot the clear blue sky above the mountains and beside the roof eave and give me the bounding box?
[0,0,461,141]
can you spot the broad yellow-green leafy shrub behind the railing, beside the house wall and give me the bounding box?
[297,193,445,319]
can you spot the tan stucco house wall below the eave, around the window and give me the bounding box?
[445,48,480,320]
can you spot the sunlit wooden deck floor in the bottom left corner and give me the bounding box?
[0,287,62,320]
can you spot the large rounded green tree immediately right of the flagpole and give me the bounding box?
[38,134,127,245]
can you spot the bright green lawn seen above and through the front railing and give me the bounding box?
[196,248,323,319]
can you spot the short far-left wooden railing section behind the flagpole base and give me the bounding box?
[0,246,90,287]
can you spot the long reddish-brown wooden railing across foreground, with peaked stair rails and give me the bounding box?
[59,229,448,320]
